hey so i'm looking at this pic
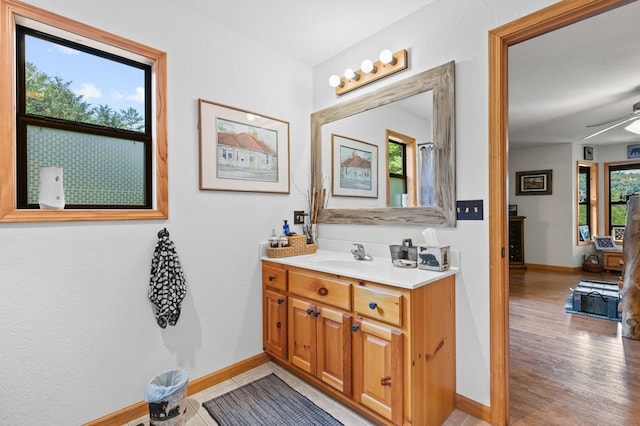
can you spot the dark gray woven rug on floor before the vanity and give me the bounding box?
[202,374,344,426]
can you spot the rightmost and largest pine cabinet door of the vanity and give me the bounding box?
[353,318,403,424]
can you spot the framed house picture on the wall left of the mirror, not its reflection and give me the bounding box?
[198,99,290,194]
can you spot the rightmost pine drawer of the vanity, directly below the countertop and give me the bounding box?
[353,287,402,326]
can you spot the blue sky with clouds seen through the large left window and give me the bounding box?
[25,35,144,117]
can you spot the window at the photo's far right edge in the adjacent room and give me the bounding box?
[605,162,640,236]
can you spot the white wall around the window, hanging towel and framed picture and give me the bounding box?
[0,0,312,425]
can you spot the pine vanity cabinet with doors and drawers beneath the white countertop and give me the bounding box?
[262,260,456,425]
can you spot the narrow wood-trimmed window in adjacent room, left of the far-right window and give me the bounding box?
[577,162,598,245]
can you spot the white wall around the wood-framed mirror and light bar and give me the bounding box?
[313,0,553,405]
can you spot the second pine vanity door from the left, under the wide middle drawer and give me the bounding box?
[289,297,319,375]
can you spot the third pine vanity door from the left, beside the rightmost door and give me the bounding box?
[316,306,351,396]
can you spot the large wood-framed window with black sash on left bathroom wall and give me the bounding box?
[0,2,167,221]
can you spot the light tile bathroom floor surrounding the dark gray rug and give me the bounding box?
[123,362,488,426]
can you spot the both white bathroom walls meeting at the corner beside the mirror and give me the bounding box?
[0,0,568,424]
